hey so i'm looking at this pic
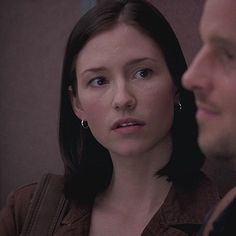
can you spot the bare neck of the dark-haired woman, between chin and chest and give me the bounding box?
[98,135,172,214]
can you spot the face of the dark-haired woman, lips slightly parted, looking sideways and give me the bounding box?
[72,24,177,156]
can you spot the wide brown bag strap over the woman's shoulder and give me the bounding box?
[21,174,68,236]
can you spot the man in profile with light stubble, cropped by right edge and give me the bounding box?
[183,0,236,236]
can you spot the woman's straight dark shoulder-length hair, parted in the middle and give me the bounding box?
[59,0,204,203]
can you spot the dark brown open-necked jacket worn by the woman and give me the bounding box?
[0,174,219,236]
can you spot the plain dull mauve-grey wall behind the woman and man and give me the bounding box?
[0,0,235,206]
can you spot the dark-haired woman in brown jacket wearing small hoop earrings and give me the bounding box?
[0,0,218,236]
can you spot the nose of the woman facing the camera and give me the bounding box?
[112,84,137,111]
